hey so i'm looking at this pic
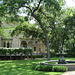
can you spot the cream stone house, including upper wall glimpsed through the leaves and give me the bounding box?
[0,22,45,53]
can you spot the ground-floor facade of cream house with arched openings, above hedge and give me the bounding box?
[0,35,45,53]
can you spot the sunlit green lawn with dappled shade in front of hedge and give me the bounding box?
[0,58,75,75]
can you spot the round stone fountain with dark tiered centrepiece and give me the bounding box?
[43,51,75,71]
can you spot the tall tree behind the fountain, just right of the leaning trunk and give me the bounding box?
[51,8,73,52]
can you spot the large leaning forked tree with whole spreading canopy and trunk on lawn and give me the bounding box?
[0,0,74,60]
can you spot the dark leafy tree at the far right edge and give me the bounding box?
[64,11,75,49]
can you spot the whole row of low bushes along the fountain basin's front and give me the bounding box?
[32,64,67,72]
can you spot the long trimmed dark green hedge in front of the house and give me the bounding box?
[0,48,33,56]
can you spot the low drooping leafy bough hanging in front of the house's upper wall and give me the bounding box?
[11,21,39,38]
